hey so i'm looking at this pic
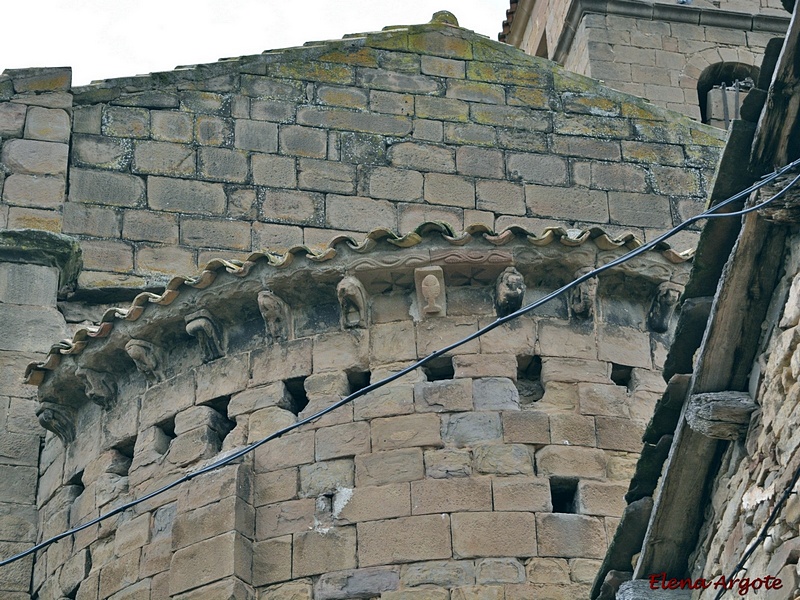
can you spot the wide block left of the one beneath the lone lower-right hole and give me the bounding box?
[452,512,537,558]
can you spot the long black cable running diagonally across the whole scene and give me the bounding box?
[0,159,800,567]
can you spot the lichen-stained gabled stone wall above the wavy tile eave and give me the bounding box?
[0,13,724,290]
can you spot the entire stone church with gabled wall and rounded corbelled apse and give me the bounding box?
[0,13,725,600]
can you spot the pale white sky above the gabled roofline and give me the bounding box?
[0,0,509,85]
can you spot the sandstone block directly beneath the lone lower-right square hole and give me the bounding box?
[536,513,607,558]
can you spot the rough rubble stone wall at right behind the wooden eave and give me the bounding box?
[690,235,800,599]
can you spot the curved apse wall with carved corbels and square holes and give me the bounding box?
[26,230,690,600]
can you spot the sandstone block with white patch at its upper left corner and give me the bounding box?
[333,483,411,523]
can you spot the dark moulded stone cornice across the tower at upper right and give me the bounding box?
[552,0,789,64]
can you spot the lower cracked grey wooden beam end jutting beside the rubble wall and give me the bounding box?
[686,392,758,440]
